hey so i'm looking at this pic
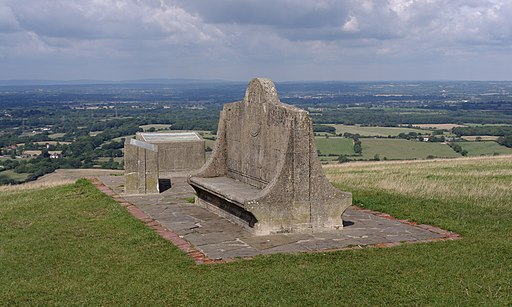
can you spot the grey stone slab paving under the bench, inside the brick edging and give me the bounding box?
[99,177,443,259]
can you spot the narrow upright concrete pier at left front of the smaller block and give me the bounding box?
[124,139,160,194]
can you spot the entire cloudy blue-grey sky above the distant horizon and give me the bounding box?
[0,0,512,81]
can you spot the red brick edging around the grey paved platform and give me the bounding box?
[86,177,462,264]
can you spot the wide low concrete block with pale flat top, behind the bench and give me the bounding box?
[135,132,205,172]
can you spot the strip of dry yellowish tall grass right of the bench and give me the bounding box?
[325,155,512,207]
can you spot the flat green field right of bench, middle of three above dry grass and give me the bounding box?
[360,138,460,160]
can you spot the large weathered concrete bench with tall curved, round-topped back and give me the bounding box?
[189,78,352,235]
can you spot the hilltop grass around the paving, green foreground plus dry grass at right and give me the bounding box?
[0,156,512,306]
